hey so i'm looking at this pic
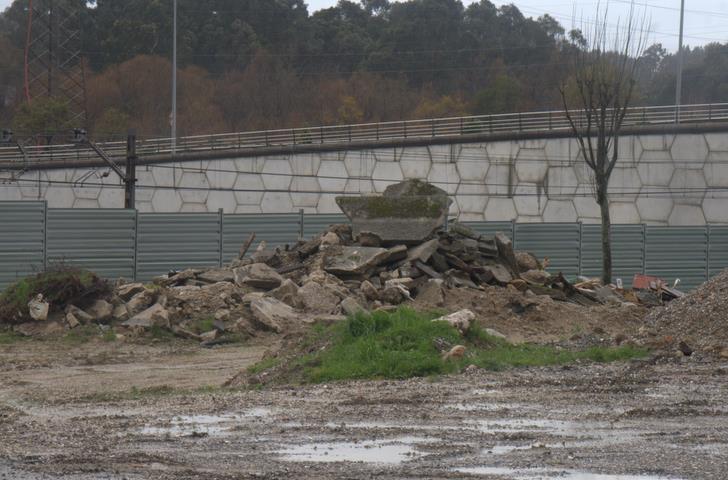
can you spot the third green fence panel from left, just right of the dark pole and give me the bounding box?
[137,213,222,281]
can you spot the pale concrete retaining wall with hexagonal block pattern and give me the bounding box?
[0,133,728,225]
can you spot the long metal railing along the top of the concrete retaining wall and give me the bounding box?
[0,103,728,166]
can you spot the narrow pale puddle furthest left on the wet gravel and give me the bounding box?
[140,408,271,437]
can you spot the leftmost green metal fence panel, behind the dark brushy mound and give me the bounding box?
[0,202,46,289]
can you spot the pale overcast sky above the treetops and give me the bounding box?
[0,0,728,50]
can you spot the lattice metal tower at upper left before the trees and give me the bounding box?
[25,0,86,127]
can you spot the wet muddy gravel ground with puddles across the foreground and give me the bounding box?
[0,341,728,480]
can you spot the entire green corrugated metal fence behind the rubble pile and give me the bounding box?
[0,201,728,289]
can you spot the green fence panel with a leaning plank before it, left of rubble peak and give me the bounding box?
[222,213,301,262]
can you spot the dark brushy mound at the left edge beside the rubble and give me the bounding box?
[0,266,110,324]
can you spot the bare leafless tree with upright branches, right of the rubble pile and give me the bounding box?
[559,4,647,284]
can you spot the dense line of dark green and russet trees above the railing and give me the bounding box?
[0,0,728,136]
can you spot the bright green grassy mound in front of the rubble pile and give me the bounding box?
[248,308,647,383]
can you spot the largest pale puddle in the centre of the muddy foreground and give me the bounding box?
[278,437,436,464]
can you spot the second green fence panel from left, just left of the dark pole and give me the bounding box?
[46,208,136,279]
